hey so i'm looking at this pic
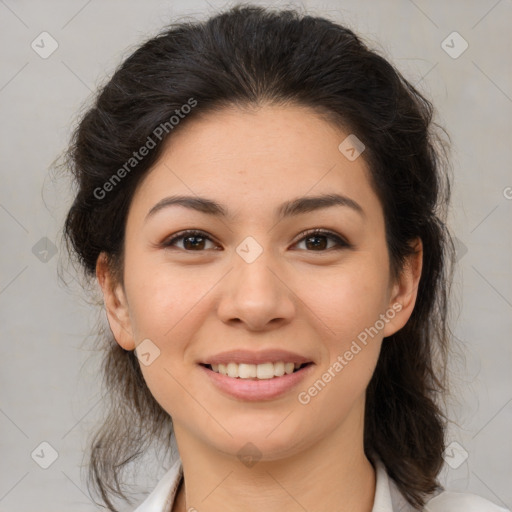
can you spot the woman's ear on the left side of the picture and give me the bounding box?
[96,252,135,350]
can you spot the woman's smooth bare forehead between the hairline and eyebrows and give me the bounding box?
[127,106,380,223]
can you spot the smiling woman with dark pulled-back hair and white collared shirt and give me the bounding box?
[61,6,504,512]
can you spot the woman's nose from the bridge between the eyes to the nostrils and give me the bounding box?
[219,237,294,329]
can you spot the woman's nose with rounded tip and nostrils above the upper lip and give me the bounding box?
[218,245,297,331]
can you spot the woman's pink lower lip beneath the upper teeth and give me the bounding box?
[199,363,314,401]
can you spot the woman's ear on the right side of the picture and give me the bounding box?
[384,238,423,337]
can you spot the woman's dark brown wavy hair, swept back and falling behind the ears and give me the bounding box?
[58,5,453,510]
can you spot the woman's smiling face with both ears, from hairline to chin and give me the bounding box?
[97,102,421,460]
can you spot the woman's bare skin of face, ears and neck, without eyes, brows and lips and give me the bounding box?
[97,105,422,512]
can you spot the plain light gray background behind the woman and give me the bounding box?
[0,0,512,512]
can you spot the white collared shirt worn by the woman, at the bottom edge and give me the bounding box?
[134,459,510,512]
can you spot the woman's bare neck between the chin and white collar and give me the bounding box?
[173,406,375,512]
